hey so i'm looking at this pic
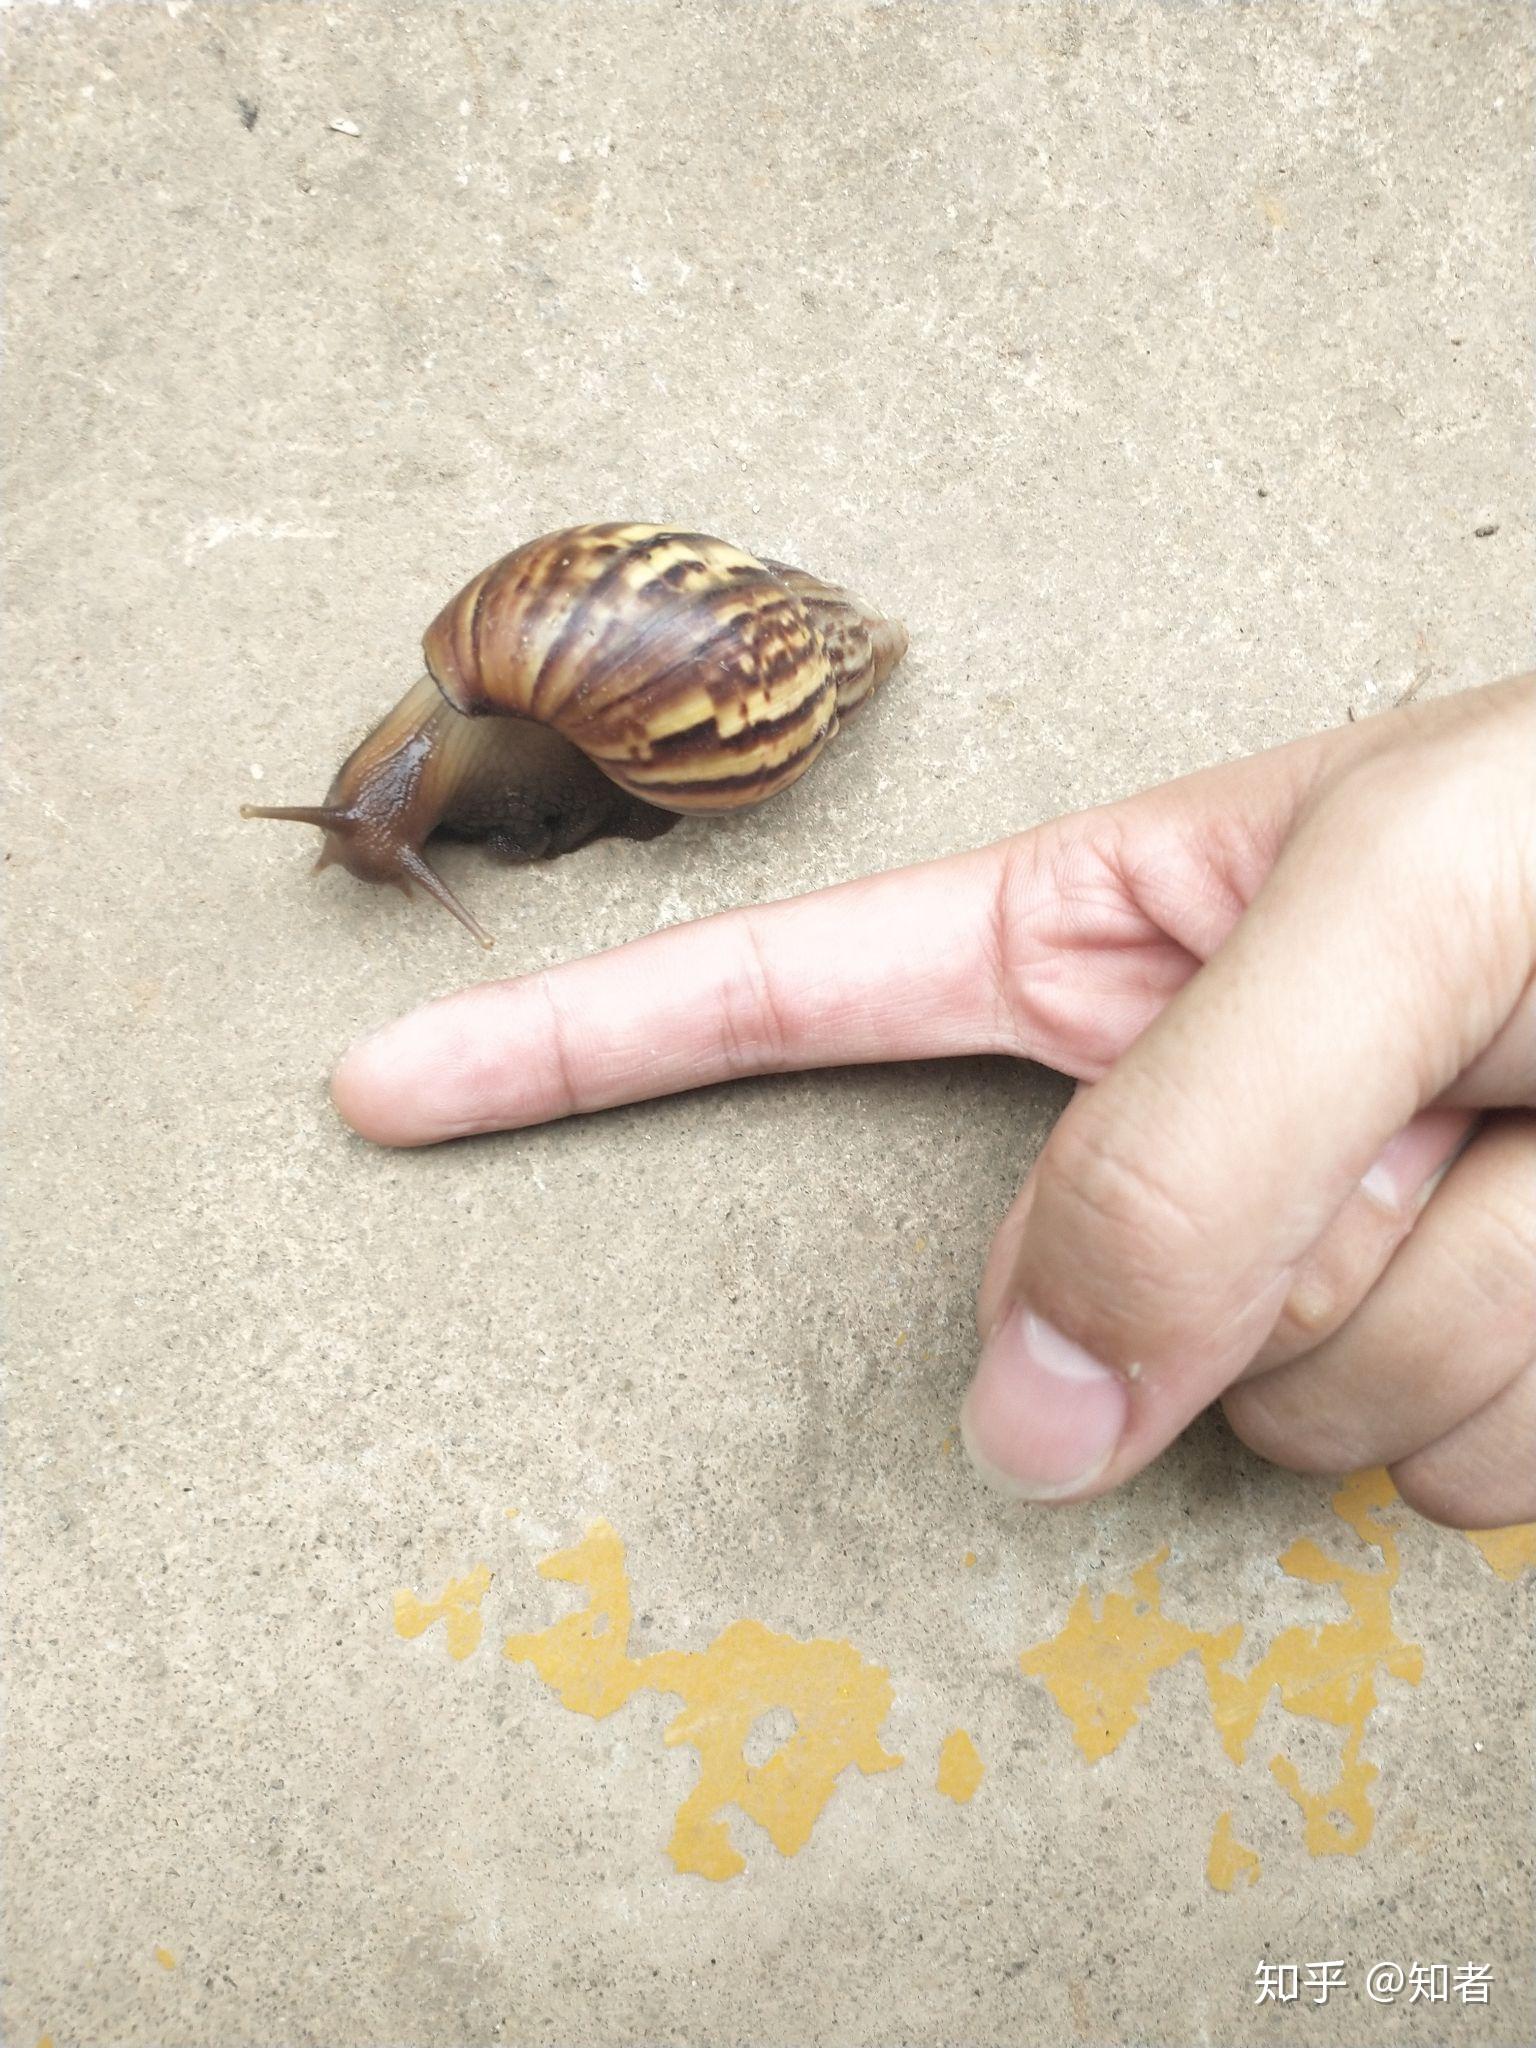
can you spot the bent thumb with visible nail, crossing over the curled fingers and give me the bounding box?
[961,698,1532,1499]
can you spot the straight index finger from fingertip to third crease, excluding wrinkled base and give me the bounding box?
[332,842,1028,1145]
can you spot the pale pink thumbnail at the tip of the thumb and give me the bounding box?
[961,1307,1130,1501]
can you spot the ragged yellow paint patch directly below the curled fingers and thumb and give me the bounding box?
[1020,1470,1423,1855]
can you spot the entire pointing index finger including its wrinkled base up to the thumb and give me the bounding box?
[332,721,1384,1145]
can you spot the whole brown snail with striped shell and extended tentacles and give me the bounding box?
[240,522,907,946]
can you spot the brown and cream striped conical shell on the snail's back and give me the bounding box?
[422,522,905,811]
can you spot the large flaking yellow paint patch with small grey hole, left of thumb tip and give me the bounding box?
[504,1522,901,1882]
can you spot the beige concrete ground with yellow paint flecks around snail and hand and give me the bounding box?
[4,0,1536,2048]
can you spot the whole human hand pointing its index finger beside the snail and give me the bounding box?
[332,676,1536,1526]
